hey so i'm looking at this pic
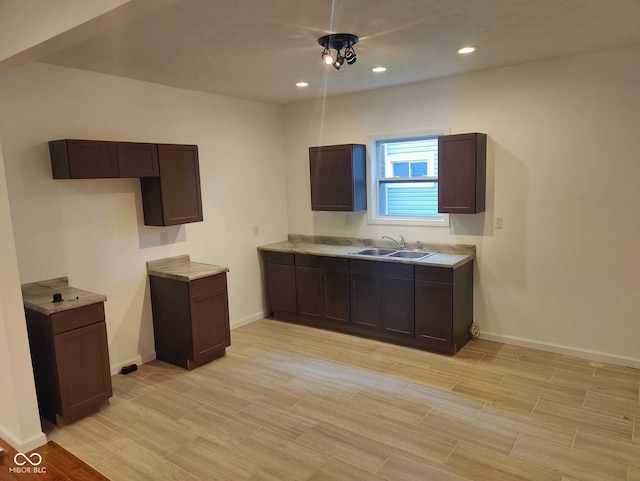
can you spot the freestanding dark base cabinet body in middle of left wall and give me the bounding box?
[149,272,231,369]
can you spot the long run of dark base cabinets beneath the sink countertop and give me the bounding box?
[263,251,473,354]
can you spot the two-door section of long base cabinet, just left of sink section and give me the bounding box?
[295,254,350,327]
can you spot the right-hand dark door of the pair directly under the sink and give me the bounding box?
[380,277,415,339]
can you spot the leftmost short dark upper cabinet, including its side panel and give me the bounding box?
[49,140,119,179]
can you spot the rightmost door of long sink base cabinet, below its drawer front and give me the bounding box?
[415,280,453,352]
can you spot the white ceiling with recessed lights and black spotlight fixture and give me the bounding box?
[42,0,640,103]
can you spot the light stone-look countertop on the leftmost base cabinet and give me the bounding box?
[22,277,107,316]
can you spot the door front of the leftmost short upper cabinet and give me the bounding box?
[67,140,119,179]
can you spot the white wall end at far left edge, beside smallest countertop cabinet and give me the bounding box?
[0,140,46,452]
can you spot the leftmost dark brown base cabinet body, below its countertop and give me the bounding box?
[25,303,112,424]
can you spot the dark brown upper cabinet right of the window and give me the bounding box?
[438,133,487,214]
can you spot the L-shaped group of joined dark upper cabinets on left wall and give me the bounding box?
[49,139,203,226]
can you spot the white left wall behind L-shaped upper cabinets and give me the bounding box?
[0,64,287,371]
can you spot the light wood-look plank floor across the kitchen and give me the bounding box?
[42,320,640,481]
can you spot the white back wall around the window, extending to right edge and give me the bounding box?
[285,47,640,367]
